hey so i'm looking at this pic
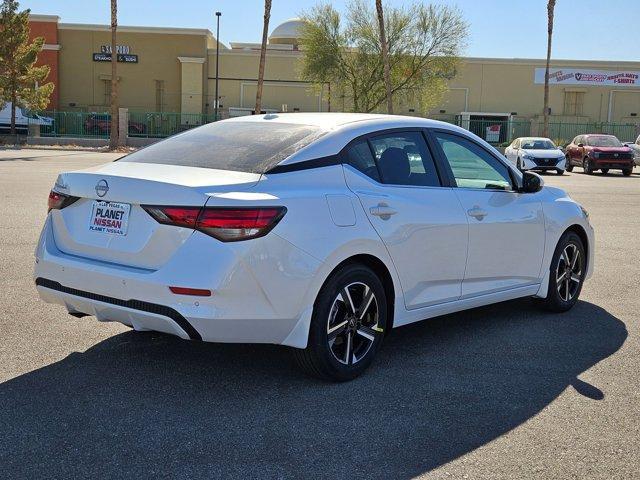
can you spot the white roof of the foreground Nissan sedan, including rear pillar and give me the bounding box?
[223,112,472,165]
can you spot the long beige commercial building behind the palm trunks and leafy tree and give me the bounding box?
[35,17,640,135]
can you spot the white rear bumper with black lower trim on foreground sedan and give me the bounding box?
[34,217,321,347]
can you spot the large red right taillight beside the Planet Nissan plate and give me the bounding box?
[143,206,287,242]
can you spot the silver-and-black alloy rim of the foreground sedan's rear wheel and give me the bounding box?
[327,282,382,365]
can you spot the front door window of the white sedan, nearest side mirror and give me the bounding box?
[434,132,513,190]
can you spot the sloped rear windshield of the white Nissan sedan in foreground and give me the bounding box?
[120,122,324,173]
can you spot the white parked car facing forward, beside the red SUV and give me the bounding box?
[504,137,566,175]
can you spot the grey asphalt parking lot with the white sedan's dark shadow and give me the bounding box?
[0,150,640,479]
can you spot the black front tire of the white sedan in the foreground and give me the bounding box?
[541,232,587,313]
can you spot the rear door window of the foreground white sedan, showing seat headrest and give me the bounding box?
[369,132,440,187]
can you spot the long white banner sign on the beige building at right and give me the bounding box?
[534,68,640,87]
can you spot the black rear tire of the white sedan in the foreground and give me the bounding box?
[293,263,387,382]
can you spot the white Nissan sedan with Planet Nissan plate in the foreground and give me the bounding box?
[35,113,594,380]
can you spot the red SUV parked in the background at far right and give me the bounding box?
[566,134,633,177]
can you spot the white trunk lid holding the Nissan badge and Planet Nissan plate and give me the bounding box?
[52,162,260,270]
